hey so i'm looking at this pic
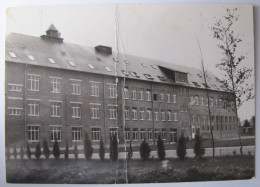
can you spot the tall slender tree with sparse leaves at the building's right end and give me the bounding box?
[210,8,254,155]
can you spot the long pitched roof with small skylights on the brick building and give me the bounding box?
[5,32,223,91]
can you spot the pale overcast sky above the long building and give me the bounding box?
[6,4,255,119]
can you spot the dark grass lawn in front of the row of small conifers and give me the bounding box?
[6,156,255,184]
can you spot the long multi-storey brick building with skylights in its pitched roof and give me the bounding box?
[5,25,237,146]
